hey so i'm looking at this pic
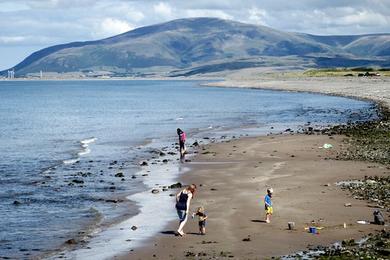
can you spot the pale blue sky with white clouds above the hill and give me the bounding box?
[0,0,390,70]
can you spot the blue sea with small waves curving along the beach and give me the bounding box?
[0,80,377,258]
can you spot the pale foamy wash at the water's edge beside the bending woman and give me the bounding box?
[61,159,186,259]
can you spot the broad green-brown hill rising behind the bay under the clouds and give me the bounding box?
[1,18,390,76]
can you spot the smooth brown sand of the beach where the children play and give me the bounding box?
[122,134,389,259]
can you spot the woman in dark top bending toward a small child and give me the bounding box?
[176,184,196,236]
